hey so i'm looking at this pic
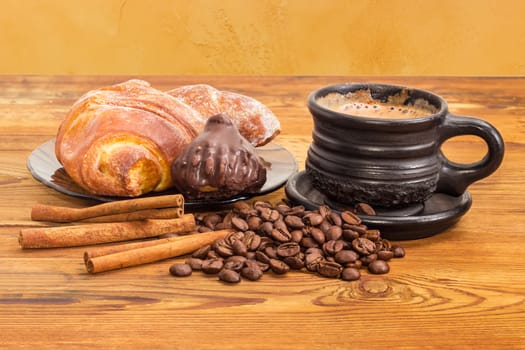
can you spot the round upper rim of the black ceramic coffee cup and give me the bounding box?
[307,82,448,125]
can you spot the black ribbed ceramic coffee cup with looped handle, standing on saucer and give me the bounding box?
[305,84,504,208]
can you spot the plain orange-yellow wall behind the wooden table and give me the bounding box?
[0,0,525,75]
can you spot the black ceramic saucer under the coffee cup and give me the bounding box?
[285,171,472,240]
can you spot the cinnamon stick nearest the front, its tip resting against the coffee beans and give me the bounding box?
[85,229,232,273]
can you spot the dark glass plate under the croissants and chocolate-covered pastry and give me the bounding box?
[27,139,297,208]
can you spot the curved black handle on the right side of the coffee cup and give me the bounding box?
[436,113,505,196]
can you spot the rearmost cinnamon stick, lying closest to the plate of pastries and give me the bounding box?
[31,194,184,222]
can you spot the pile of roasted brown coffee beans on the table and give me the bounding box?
[170,201,405,283]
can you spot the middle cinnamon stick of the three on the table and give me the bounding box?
[18,214,195,248]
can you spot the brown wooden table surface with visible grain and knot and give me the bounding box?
[0,76,525,349]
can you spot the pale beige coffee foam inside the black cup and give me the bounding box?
[317,89,437,119]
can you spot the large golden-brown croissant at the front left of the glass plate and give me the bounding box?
[55,80,206,196]
